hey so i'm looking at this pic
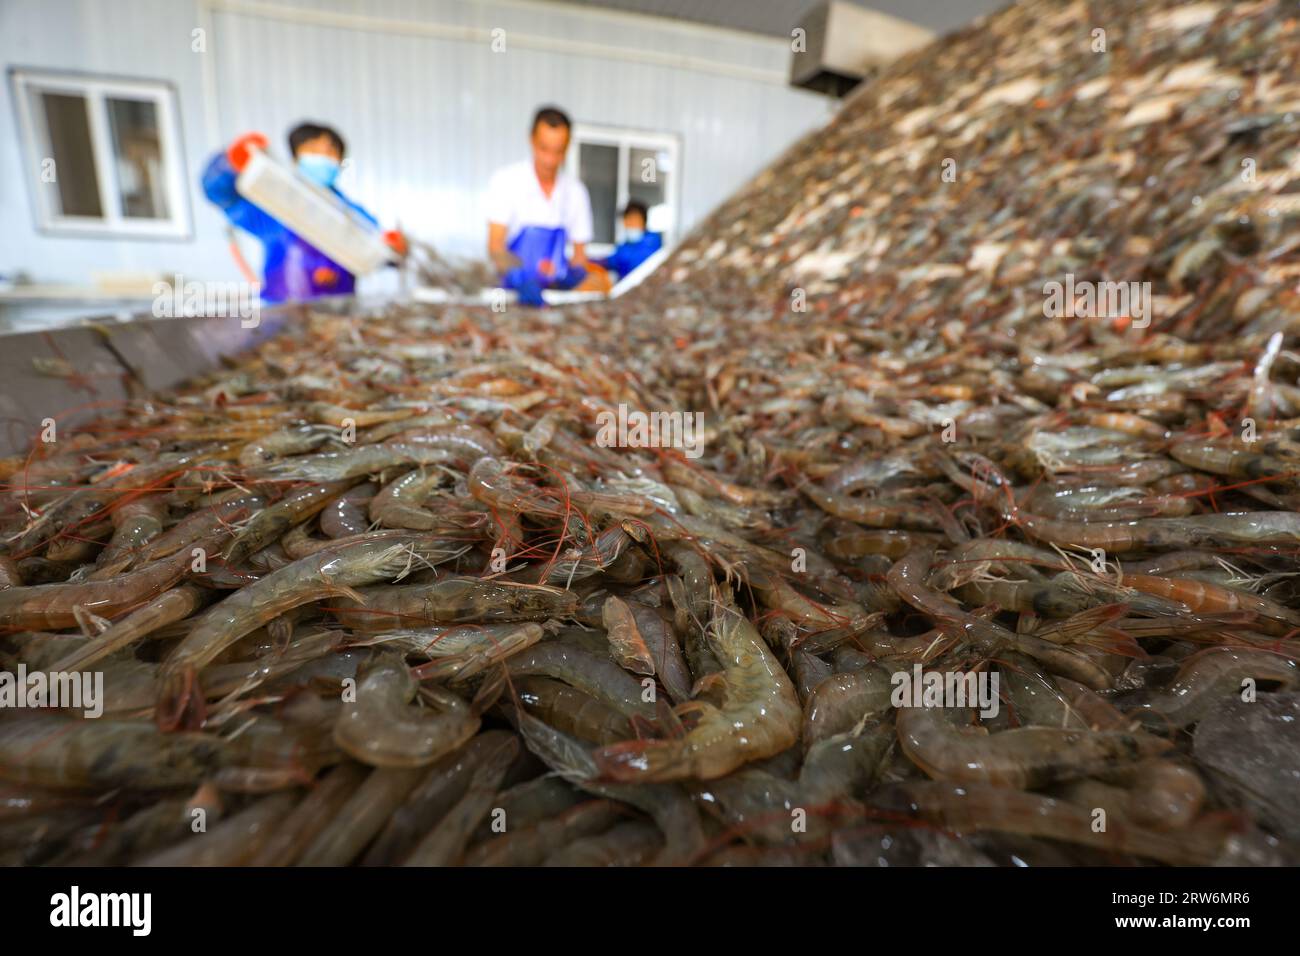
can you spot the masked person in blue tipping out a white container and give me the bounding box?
[203,122,406,302]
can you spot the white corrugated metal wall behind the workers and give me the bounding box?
[0,0,832,295]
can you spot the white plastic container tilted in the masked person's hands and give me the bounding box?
[235,147,393,276]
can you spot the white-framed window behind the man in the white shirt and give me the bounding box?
[568,124,681,255]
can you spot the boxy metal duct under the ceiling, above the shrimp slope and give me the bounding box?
[790,0,935,96]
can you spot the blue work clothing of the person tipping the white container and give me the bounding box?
[203,152,380,302]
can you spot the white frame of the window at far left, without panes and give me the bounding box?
[10,68,191,239]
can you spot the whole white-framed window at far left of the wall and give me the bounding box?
[12,69,190,237]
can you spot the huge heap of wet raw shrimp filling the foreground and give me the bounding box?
[0,0,1300,866]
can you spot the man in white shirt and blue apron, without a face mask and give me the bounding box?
[488,107,610,306]
